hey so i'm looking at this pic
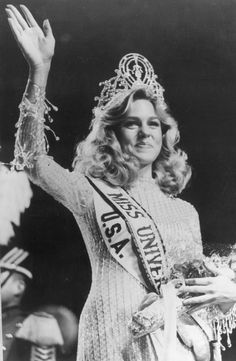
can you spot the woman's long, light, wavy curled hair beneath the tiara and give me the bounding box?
[73,88,191,195]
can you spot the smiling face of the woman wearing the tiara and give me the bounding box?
[117,99,162,167]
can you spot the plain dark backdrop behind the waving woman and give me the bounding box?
[0,0,236,358]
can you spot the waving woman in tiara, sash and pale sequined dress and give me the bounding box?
[6,5,230,361]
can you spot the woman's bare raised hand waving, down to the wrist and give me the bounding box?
[5,5,55,71]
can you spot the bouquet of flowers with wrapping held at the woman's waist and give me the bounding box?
[130,247,236,339]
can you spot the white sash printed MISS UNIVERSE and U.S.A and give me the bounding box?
[86,177,168,293]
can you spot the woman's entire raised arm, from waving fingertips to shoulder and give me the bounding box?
[6,5,83,212]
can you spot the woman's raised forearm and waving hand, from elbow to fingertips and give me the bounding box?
[6,5,55,169]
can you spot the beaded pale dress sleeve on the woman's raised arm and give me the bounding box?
[12,81,86,213]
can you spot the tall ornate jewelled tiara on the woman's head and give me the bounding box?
[94,53,167,111]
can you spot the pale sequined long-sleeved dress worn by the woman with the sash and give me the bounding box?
[14,93,202,361]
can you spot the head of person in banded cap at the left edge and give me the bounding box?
[0,247,33,311]
